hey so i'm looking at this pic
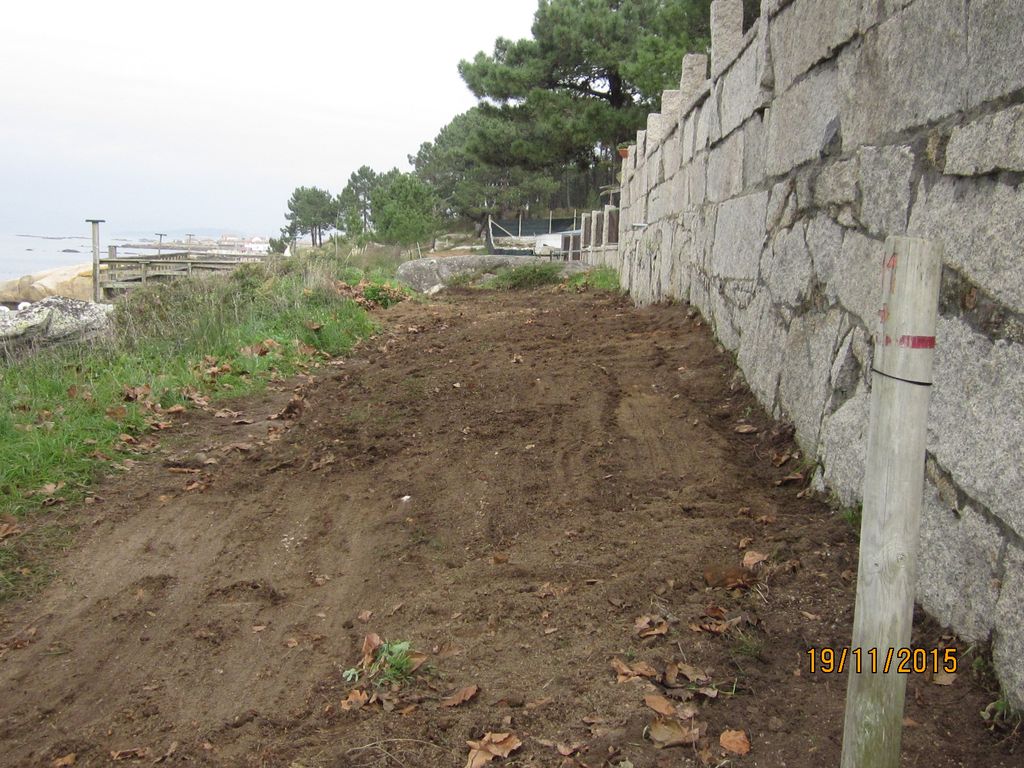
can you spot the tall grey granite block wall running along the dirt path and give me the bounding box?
[592,0,1024,706]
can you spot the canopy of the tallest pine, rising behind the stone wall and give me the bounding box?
[459,0,711,169]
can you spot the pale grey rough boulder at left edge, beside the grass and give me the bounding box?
[0,296,114,355]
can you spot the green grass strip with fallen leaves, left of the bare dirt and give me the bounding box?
[0,256,380,600]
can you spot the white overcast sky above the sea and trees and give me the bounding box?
[0,0,537,234]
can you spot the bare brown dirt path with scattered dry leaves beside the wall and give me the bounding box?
[0,291,1021,768]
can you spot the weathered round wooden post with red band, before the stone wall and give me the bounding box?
[841,238,942,768]
